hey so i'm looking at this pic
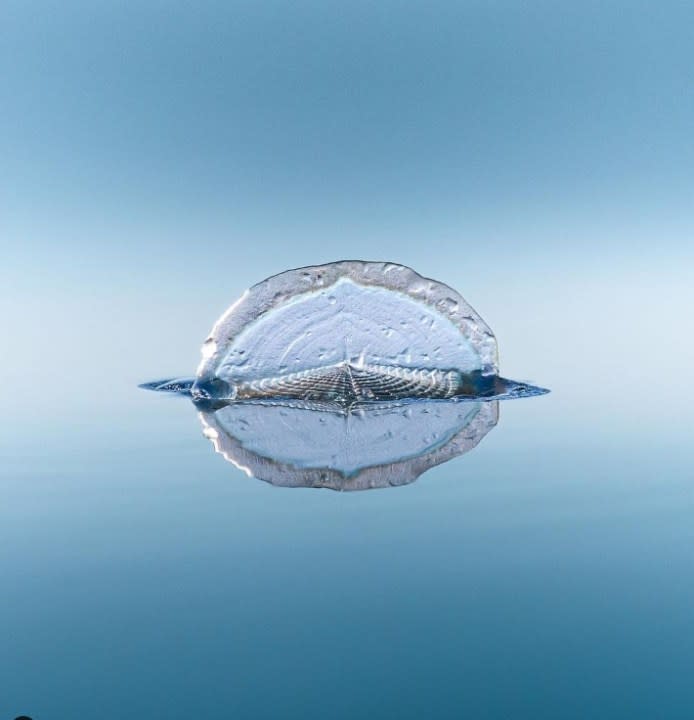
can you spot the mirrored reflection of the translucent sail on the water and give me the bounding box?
[200,400,499,490]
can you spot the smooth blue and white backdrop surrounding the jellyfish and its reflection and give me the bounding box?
[0,0,694,720]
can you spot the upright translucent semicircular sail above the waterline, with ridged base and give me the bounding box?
[193,261,498,402]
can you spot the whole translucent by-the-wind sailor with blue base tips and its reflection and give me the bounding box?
[142,261,547,490]
